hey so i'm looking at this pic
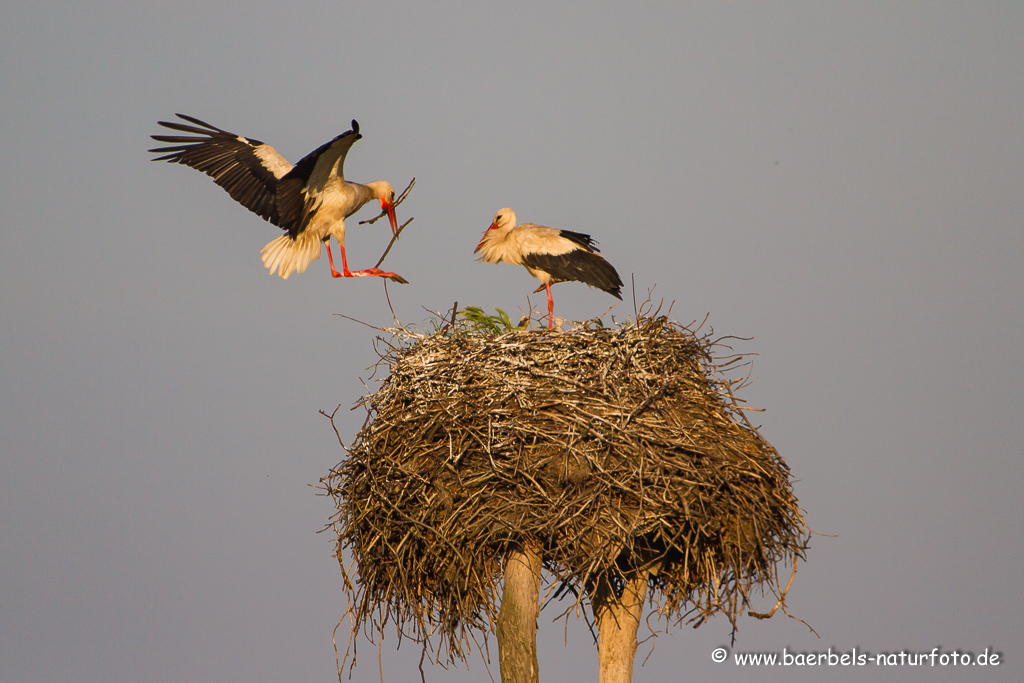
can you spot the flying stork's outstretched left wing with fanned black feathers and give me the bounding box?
[150,114,293,225]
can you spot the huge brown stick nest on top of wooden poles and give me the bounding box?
[324,317,808,661]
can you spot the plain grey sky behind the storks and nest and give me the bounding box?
[0,0,1024,683]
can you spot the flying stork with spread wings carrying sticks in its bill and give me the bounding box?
[150,114,406,283]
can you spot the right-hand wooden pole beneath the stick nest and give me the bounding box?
[591,572,647,683]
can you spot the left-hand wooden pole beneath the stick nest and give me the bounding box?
[497,547,541,683]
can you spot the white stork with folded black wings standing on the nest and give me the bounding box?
[473,209,623,330]
